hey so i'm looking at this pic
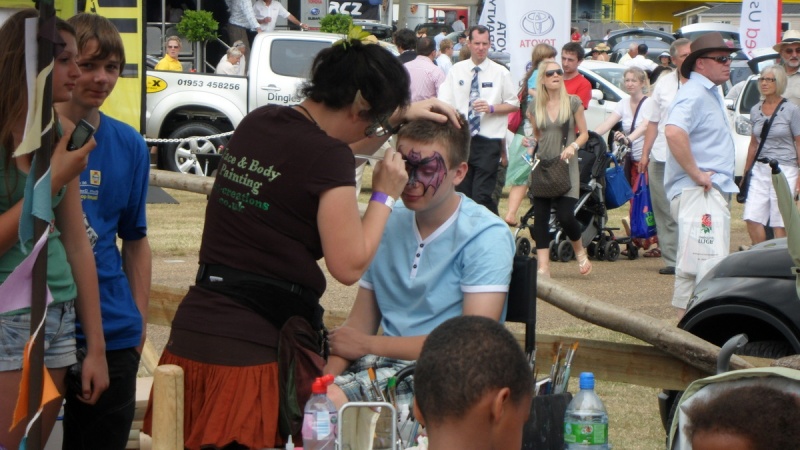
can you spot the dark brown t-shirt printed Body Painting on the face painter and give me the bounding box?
[200,106,355,296]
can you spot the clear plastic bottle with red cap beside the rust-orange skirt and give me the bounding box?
[303,375,339,450]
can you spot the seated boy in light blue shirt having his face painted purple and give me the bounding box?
[325,117,514,432]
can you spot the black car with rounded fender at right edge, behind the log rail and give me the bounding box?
[659,238,800,429]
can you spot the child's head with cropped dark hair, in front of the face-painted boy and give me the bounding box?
[414,316,533,450]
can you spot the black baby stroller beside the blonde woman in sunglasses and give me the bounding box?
[514,131,631,262]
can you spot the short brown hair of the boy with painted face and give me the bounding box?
[397,114,470,169]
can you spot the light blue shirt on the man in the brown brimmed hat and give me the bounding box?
[664,72,739,199]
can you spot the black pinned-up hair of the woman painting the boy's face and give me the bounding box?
[300,40,410,119]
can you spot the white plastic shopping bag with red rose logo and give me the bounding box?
[675,186,731,275]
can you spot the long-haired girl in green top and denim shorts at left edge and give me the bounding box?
[0,9,108,448]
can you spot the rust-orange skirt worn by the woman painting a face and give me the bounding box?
[143,349,284,450]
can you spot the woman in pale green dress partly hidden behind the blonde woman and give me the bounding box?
[505,44,556,227]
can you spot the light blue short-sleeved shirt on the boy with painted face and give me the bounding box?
[359,194,514,336]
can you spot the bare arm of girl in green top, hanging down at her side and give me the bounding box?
[55,178,108,404]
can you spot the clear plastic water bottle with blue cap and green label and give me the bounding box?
[564,372,609,450]
